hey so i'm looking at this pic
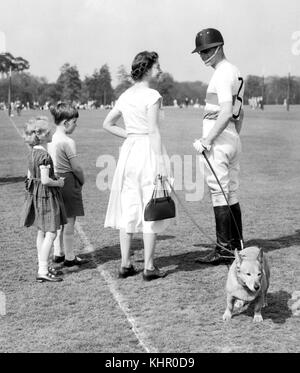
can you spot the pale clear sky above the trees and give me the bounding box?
[0,0,300,84]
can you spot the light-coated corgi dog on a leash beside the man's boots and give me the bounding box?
[223,246,270,322]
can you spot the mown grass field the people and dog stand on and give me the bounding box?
[0,106,300,353]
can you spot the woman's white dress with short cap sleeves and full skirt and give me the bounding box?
[104,86,169,233]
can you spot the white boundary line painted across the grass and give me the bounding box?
[8,113,158,353]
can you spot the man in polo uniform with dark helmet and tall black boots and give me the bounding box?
[192,28,244,264]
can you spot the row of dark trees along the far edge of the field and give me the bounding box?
[0,63,300,107]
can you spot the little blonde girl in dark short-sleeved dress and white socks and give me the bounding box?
[22,117,67,282]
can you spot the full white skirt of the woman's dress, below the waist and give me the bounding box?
[104,134,170,233]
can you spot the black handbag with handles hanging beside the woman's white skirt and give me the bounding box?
[144,176,176,221]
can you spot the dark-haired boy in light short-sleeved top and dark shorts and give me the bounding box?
[48,102,87,267]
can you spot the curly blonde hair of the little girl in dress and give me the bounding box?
[23,117,51,146]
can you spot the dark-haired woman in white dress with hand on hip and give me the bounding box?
[103,51,171,281]
